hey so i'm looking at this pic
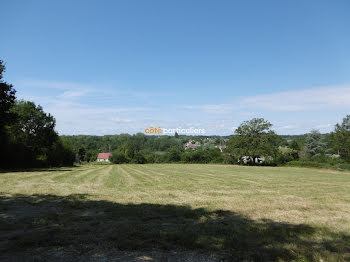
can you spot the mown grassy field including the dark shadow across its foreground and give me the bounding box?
[0,164,350,261]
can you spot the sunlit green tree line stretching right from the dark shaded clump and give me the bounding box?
[62,116,350,169]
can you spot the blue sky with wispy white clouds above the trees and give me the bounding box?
[0,0,350,135]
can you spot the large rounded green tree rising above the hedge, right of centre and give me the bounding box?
[228,118,279,163]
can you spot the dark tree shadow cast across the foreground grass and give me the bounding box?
[0,195,350,261]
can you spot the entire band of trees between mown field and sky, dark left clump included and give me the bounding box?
[0,61,350,168]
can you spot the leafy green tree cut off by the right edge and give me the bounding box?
[330,115,350,162]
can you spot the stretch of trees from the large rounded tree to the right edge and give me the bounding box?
[227,115,350,169]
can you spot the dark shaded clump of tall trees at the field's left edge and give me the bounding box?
[0,60,75,168]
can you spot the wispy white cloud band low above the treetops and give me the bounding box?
[15,80,350,135]
